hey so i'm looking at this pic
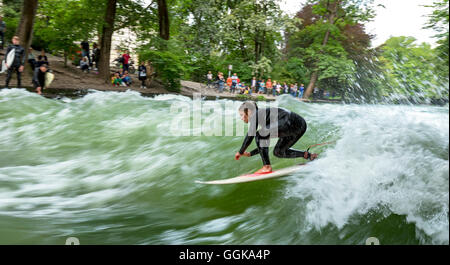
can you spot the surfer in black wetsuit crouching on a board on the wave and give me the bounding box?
[235,101,317,174]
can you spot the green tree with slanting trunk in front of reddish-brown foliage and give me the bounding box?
[294,0,375,98]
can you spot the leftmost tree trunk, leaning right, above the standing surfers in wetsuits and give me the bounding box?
[16,0,38,68]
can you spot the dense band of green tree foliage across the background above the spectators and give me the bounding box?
[2,0,449,102]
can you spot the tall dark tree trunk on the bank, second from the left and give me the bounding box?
[98,0,117,83]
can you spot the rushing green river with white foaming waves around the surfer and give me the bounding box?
[0,89,449,245]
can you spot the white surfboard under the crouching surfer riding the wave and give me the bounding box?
[195,163,306,185]
